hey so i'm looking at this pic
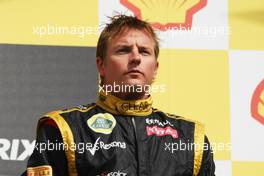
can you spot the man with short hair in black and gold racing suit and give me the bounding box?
[22,15,215,176]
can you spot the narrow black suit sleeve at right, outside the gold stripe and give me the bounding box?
[198,136,215,176]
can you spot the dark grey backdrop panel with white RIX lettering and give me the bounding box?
[0,45,97,175]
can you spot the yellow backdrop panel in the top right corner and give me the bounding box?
[229,0,264,50]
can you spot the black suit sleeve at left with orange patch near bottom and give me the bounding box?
[22,121,68,176]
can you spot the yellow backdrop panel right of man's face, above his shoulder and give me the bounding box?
[153,49,230,160]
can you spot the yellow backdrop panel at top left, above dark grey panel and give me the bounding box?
[0,0,98,46]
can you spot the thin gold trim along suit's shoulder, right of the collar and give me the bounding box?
[154,109,204,126]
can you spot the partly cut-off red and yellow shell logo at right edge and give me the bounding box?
[251,80,264,125]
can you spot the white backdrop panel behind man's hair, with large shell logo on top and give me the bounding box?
[99,0,230,49]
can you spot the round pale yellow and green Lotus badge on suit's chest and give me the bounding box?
[87,113,116,134]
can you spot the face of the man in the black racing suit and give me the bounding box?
[97,29,158,90]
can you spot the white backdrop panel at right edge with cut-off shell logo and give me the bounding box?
[229,51,264,161]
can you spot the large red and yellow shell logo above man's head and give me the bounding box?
[120,0,207,31]
